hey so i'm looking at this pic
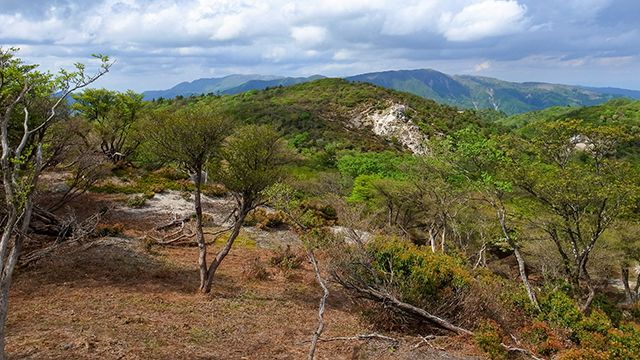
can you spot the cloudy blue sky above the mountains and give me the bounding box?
[0,0,640,91]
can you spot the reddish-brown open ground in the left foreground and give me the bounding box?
[2,193,482,359]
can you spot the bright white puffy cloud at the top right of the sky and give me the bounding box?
[439,0,527,41]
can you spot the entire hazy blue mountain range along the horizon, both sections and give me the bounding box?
[144,69,640,114]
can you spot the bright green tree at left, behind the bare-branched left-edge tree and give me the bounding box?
[73,89,143,164]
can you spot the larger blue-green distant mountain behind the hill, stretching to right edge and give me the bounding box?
[346,69,640,114]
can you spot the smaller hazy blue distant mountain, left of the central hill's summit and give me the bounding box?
[143,74,323,100]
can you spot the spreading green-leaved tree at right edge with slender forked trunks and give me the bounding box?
[512,120,640,311]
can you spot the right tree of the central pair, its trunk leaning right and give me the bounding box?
[201,125,291,293]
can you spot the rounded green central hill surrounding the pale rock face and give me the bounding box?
[156,79,490,150]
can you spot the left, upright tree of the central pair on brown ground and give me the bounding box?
[145,102,233,292]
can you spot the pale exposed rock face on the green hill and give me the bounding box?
[351,103,429,154]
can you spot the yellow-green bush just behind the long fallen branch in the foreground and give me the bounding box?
[329,237,472,319]
